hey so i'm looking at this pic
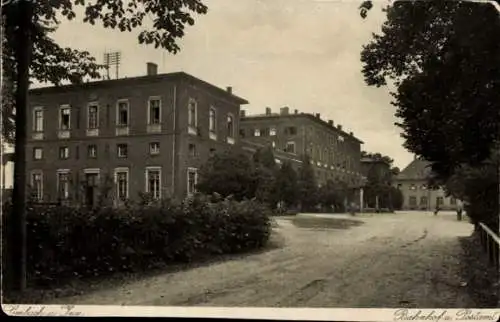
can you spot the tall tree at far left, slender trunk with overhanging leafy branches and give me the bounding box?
[2,0,207,290]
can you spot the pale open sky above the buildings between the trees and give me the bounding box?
[1,0,413,189]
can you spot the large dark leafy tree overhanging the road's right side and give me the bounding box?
[361,1,500,178]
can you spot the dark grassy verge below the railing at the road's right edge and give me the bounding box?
[460,233,500,308]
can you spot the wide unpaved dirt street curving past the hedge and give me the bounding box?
[48,212,472,308]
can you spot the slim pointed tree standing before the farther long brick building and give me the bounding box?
[298,154,318,211]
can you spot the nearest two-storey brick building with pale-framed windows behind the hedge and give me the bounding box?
[27,63,248,204]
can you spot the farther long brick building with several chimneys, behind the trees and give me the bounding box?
[240,107,363,188]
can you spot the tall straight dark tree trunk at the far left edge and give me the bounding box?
[11,0,33,291]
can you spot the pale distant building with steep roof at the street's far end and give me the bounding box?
[394,158,457,210]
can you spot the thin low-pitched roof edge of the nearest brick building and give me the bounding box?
[29,72,248,104]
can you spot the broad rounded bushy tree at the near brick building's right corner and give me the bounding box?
[197,150,257,200]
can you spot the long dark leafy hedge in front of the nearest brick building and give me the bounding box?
[3,195,271,286]
